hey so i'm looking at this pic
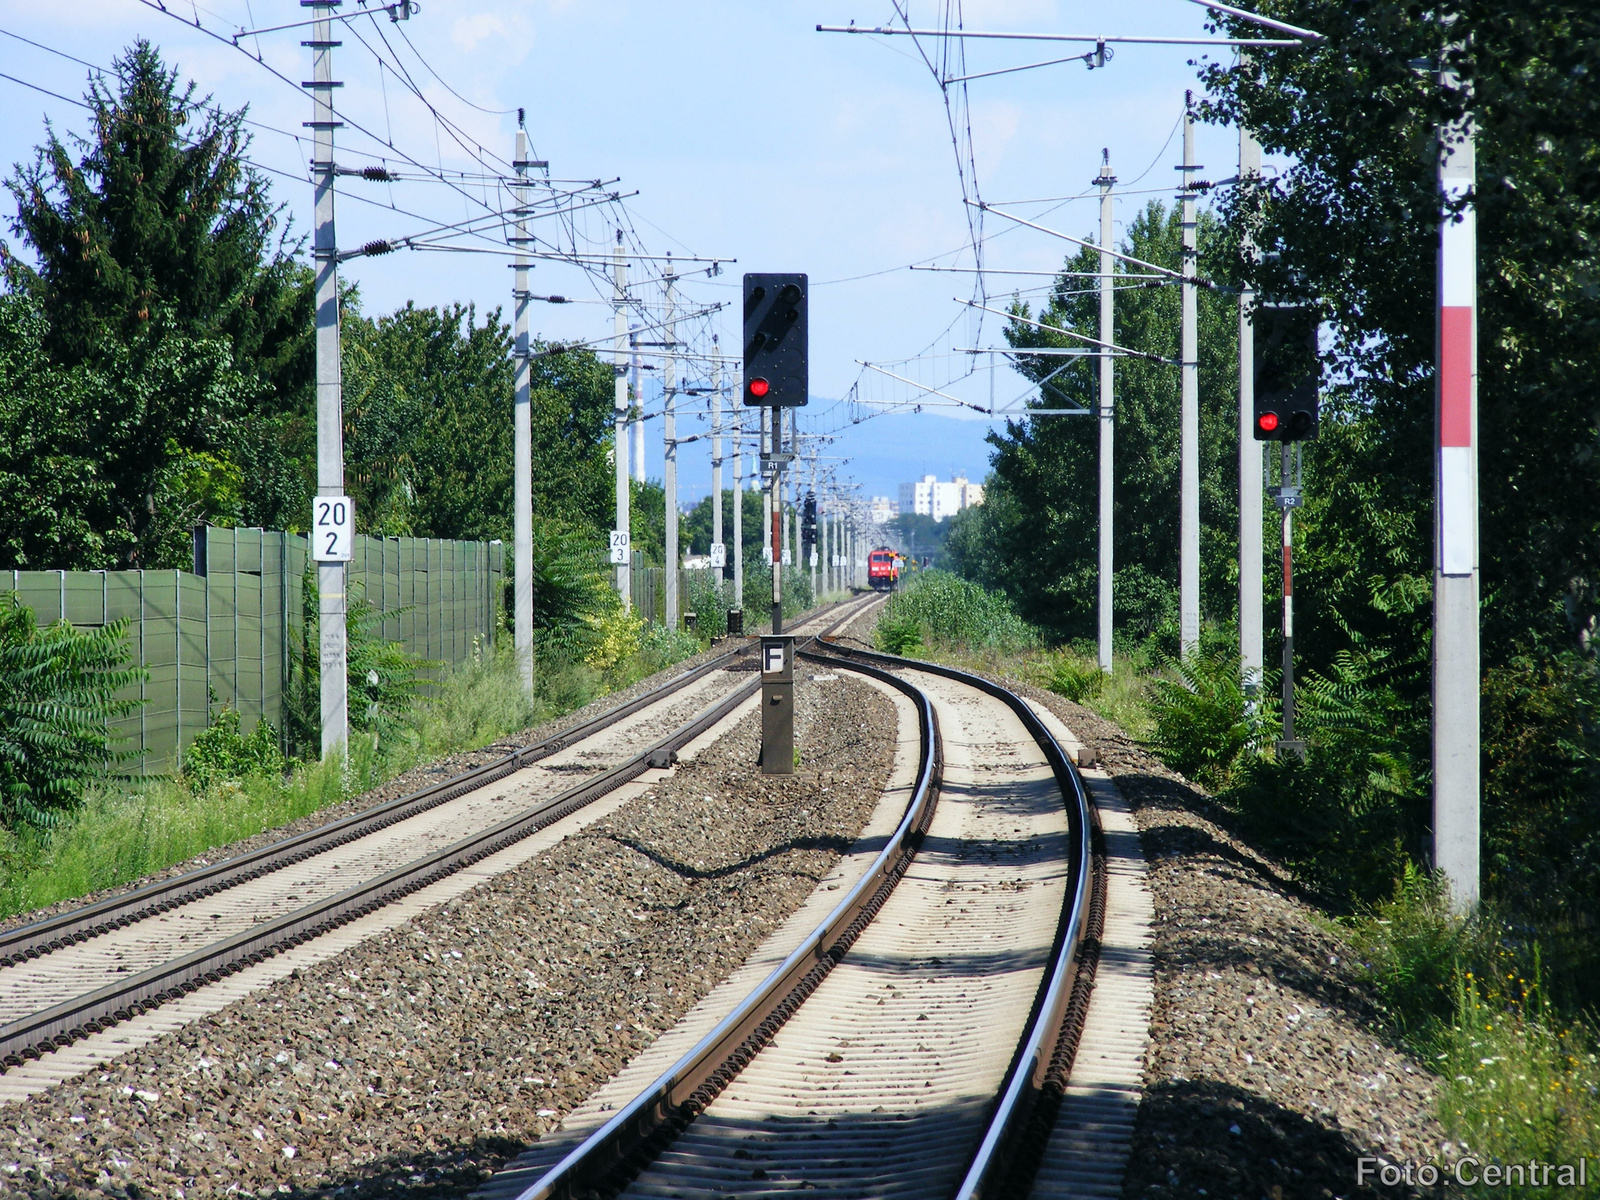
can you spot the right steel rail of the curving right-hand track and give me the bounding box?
[830,645,1098,1200]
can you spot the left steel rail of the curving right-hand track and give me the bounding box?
[517,651,941,1200]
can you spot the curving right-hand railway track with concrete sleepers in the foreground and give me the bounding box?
[480,648,1104,1200]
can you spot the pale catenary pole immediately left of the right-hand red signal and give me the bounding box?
[1238,126,1266,702]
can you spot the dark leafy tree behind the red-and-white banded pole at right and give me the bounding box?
[1205,0,1600,1002]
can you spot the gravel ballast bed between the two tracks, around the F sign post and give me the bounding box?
[0,669,896,1200]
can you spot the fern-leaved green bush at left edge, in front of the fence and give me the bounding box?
[0,592,146,829]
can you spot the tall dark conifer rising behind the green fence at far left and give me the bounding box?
[0,42,312,566]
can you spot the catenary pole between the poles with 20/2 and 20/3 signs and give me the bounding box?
[510,128,533,696]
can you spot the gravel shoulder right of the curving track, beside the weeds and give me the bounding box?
[848,604,1446,1200]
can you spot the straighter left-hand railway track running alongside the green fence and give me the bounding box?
[0,598,874,1099]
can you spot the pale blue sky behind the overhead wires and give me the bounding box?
[0,0,1273,498]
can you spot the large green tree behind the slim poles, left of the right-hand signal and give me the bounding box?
[947,202,1238,649]
